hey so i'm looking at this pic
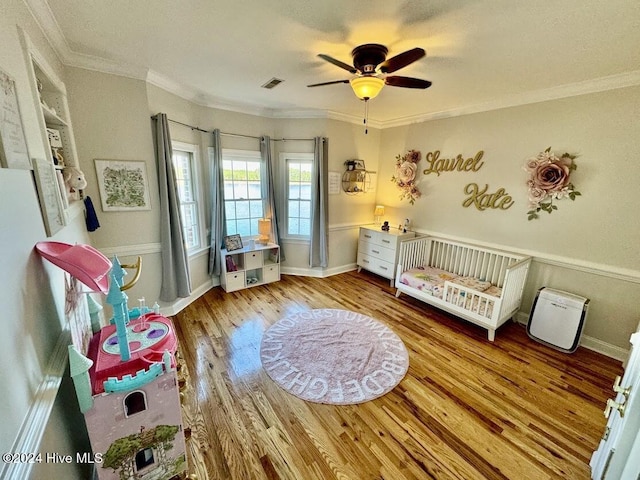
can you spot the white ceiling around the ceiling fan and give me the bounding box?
[25,0,640,127]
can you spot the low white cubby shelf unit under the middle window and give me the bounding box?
[220,243,280,292]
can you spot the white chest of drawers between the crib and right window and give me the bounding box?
[357,227,416,286]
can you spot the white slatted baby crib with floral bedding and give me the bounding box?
[395,236,531,341]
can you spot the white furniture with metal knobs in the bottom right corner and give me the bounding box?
[589,332,640,480]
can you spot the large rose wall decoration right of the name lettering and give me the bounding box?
[525,147,580,220]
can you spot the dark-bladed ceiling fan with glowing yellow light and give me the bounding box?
[307,43,431,102]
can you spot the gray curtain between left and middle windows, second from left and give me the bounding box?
[209,128,225,276]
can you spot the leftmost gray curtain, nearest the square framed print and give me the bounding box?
[154,113,191,302]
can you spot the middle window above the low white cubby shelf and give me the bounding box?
[222,149,266,237]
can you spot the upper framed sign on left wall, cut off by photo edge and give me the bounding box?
[0,70,32,170]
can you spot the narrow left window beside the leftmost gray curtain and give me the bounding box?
[171,142,204,250]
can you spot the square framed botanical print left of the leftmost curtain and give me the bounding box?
[95,160,151,212]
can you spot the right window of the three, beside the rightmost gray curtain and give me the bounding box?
[281,153,313,237]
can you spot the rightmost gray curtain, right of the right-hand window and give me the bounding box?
[309,137,329,268]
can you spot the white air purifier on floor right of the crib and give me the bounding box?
[527,287,589,353]
